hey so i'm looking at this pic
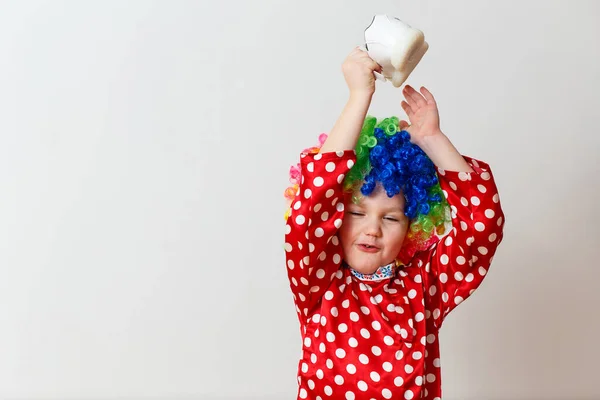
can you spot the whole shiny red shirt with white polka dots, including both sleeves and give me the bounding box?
[285,150,504,400]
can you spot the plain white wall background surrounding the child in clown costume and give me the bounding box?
[0,0,600,400]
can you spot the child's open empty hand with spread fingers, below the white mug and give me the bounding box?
[399,85,442,145]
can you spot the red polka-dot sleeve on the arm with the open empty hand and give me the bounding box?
[416,157,504,328]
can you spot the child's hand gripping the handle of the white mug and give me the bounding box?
[342,47,382,95]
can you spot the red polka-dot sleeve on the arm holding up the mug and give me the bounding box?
[284,150,356,323]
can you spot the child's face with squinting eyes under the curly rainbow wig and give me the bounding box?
[339,186,409,274]
